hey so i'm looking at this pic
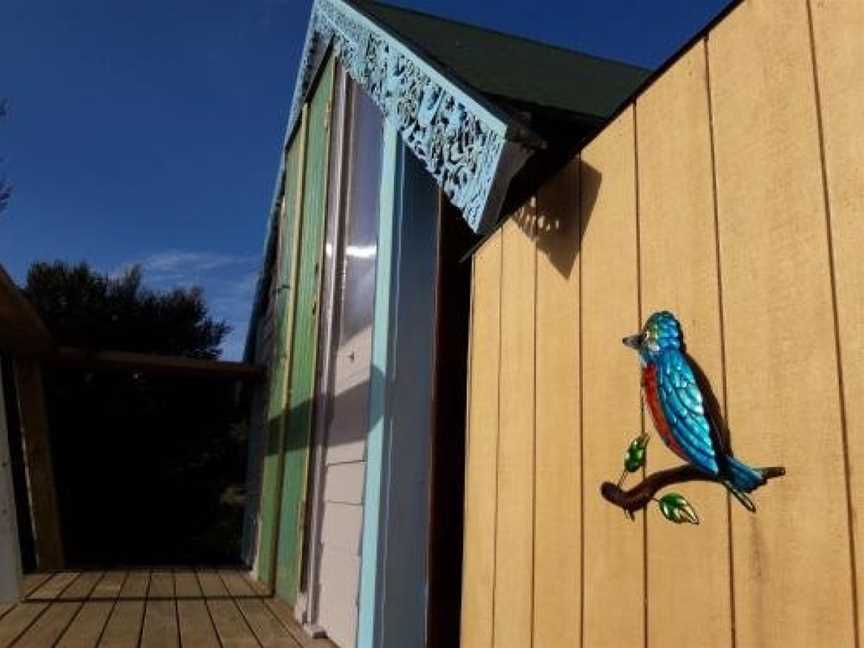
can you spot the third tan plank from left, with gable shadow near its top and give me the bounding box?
[534,159,582,648]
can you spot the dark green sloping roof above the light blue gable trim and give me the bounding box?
[357,2,651,120]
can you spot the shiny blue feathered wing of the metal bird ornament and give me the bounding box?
[657,349,719,475]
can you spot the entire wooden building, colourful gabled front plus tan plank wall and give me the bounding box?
[236,0,864,648]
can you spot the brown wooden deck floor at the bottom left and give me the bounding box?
[0,569,335,648]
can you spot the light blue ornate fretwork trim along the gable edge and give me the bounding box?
[288,0,542,232]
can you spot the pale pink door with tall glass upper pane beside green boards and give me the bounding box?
[303,71,383,648]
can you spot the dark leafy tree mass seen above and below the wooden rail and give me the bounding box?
[24,262,246,564]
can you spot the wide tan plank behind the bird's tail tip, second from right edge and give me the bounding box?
[709,0,854,648]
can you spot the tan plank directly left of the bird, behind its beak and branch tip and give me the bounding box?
[581,108,646,648]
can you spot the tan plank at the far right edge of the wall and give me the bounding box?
[810,0,864,641]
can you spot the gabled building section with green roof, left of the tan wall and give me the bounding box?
[238,0,648,648]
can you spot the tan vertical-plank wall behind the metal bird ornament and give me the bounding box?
[462,0,864,648]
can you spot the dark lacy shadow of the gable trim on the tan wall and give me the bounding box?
[512,158,602,279]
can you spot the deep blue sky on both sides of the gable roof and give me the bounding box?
[0,0,727,358]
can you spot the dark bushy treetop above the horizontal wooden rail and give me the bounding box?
[24,261,229,358]
